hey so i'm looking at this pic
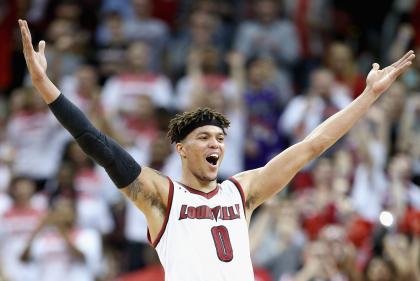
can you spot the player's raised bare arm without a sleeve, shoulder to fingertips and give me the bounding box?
[235,51,415,212]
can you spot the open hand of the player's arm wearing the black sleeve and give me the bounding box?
[19,20,47,82]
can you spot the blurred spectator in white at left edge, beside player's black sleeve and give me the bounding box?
[6,88,70,189]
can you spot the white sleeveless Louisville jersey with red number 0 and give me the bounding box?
[152,178,254,281]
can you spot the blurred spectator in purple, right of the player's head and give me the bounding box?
[243,58,293,169]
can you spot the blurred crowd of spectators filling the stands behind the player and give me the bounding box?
[0,0,420,281]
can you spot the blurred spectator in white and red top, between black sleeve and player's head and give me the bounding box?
[101,42,172,145]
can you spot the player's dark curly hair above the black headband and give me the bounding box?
[168,107,230,143]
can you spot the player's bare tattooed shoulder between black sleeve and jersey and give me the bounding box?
[121,167,169,213]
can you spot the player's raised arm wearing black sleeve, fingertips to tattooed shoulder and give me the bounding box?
[19,20,168,237]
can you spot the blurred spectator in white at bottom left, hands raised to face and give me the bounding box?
[21,198,102,281]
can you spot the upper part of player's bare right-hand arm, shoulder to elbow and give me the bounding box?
[247,141,318,209]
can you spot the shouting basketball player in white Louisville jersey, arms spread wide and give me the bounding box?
[19,20,415,281]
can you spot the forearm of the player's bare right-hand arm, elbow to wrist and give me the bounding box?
[305,89,379,154]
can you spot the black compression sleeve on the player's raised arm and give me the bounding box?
[48,94,141,188]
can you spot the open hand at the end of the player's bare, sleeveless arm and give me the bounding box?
[366,51,416,95]
